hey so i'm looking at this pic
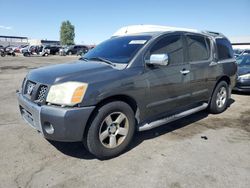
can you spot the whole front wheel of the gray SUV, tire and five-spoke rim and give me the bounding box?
[84,101,135,159]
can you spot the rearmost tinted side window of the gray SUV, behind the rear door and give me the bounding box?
[216,39,234,60]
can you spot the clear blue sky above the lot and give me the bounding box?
[0,0,250,44]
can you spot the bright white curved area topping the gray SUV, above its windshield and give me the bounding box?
[112,25,199,36]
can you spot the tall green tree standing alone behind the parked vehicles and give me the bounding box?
[60,20,75,45]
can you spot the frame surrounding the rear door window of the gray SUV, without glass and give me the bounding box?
[184,33,213,64]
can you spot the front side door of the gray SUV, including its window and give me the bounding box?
[145,34,190,117]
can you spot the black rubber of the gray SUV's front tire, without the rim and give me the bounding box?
[85,101,135,159]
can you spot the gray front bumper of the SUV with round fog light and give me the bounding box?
[17,92,95,142]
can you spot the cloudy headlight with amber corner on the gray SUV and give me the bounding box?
[46,82,88,106]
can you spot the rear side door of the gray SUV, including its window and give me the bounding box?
[186,34,212,103]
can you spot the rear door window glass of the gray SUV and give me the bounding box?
[187,35,210,62]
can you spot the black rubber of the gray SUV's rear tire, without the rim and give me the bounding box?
[210,81,229,114]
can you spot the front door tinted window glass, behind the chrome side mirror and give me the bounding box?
[150,35,184,64]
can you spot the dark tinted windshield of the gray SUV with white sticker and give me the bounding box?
[83,36,151,64]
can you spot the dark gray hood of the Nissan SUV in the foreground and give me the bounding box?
[27,61,121,85]
